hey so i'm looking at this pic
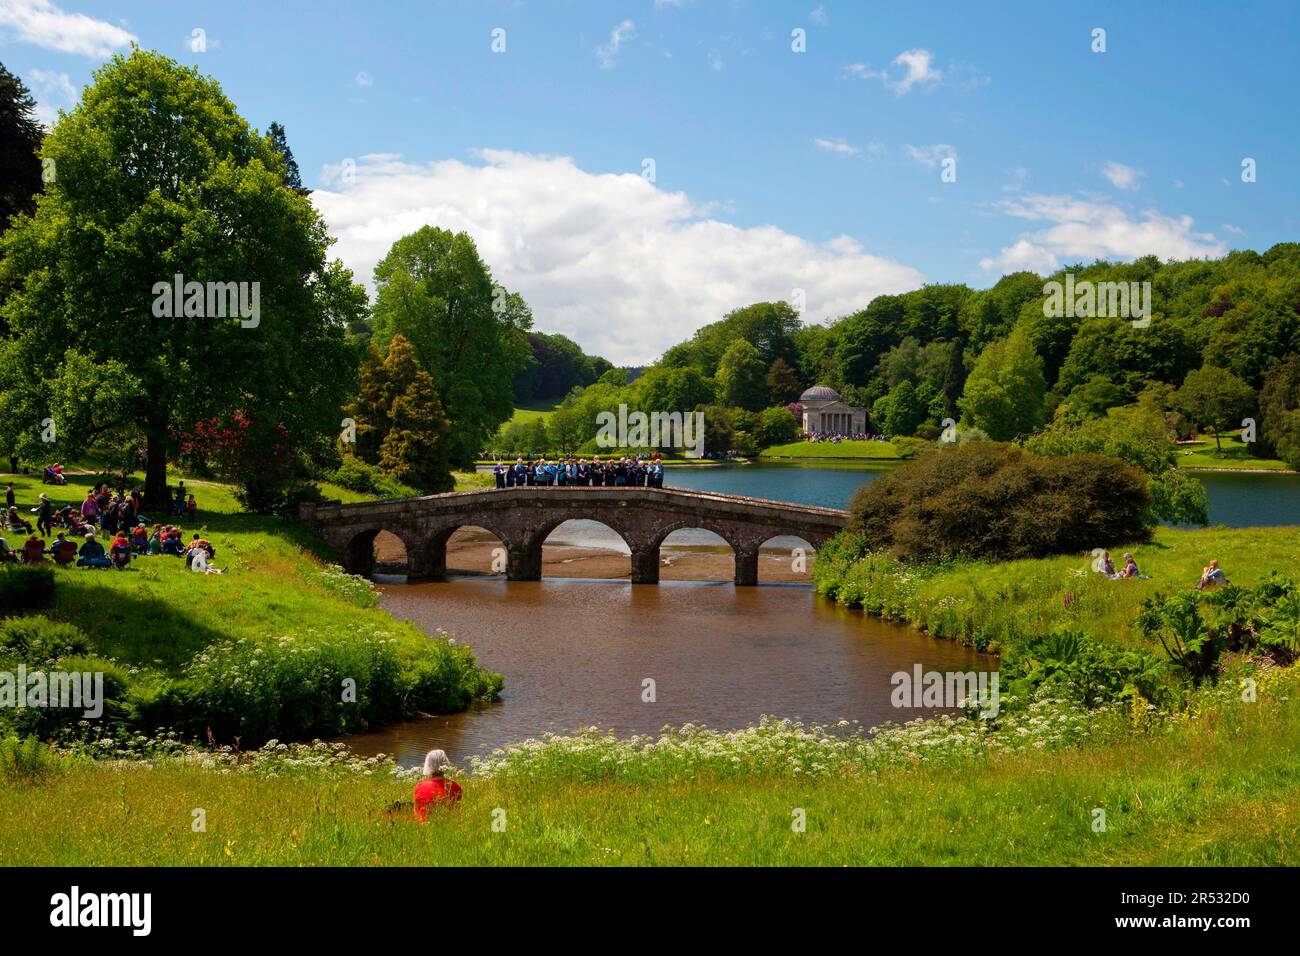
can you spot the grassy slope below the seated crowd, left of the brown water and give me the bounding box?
[0,476,501,745]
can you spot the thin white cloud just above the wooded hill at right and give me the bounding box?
[980,195,1227,273]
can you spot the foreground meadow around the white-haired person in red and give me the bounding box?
[0,665,1300,866]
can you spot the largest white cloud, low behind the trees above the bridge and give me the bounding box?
[312,150,922,364]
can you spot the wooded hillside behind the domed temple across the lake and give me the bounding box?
[501,251,1300,478]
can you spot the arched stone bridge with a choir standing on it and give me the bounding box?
[302,486,848,584]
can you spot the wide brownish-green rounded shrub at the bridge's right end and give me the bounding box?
[849,441,1151,561]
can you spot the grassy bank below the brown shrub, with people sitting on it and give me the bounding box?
[813,527,1300,650]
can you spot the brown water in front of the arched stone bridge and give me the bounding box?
[348,578,977,765]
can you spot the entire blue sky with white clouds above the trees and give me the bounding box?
[0,0,1300,364]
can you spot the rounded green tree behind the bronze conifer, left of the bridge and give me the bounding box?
[372,226,533,467]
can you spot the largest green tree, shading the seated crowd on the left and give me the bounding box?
[0,49,356,503]
